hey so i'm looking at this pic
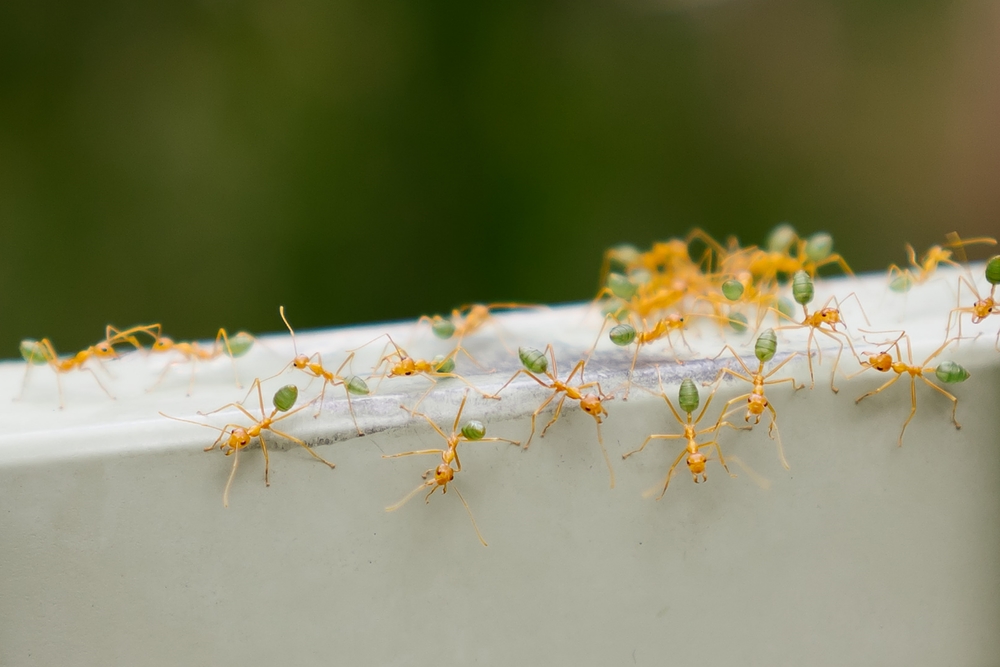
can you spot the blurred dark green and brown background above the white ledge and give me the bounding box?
[0,0,1000,357]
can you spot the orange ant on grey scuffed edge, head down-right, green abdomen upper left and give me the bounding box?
[493,345,615,489]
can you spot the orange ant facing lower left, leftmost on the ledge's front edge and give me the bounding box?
[160,379,336,507]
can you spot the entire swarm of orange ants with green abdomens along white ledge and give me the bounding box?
[21,225,1000,545]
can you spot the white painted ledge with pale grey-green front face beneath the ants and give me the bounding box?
[0,272,1000,666]
